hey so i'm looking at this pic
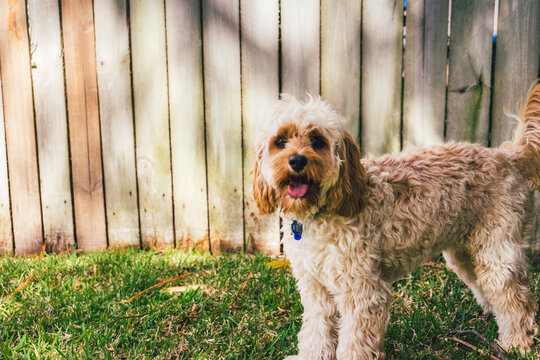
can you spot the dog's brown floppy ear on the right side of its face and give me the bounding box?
[327,132,367,217]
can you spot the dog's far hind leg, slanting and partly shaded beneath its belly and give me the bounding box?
[443,247,492,313]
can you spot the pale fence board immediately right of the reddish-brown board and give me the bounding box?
[94,0,139,247]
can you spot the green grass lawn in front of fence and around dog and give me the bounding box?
[0,250,540,359]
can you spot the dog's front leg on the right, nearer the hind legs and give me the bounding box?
[336,280,391,360]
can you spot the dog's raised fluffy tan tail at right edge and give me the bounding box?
[513,79,540,190]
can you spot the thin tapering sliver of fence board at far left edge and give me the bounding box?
[0,75,13,255]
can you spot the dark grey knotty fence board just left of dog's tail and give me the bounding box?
[446,0,495,145]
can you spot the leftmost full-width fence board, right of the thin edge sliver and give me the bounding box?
[0,0,43,254]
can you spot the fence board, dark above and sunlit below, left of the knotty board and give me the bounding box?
[403,0,448,147]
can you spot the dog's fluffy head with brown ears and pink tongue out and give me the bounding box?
[253,96,366,217]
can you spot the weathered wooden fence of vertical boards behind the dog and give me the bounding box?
[0,0,540,254]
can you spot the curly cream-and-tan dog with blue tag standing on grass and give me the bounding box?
[253,82,540,360]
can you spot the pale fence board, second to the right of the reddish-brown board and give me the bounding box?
[130,0,174,248]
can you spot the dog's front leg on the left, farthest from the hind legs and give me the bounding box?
[287,274,338,360]
